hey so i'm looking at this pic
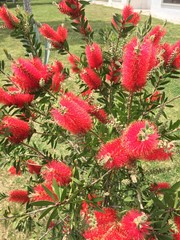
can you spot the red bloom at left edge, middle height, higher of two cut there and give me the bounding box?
[0,87,34,108]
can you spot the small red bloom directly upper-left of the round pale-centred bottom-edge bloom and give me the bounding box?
[94,208,118,226]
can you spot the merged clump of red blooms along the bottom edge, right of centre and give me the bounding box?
[83,208,151,240]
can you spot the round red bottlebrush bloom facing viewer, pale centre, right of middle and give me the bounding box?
[122,120,159,158]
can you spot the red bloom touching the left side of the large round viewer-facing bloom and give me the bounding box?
[97,138,130,169]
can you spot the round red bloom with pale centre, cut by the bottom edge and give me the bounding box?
[121,210,151,240]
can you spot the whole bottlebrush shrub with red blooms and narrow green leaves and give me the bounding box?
[0,0,180,240]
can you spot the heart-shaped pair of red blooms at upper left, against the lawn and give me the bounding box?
[39,24,68,49]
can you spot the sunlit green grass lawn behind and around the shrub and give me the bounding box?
[0,0,180,240]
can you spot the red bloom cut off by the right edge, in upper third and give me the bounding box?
[162,41,180,69]
